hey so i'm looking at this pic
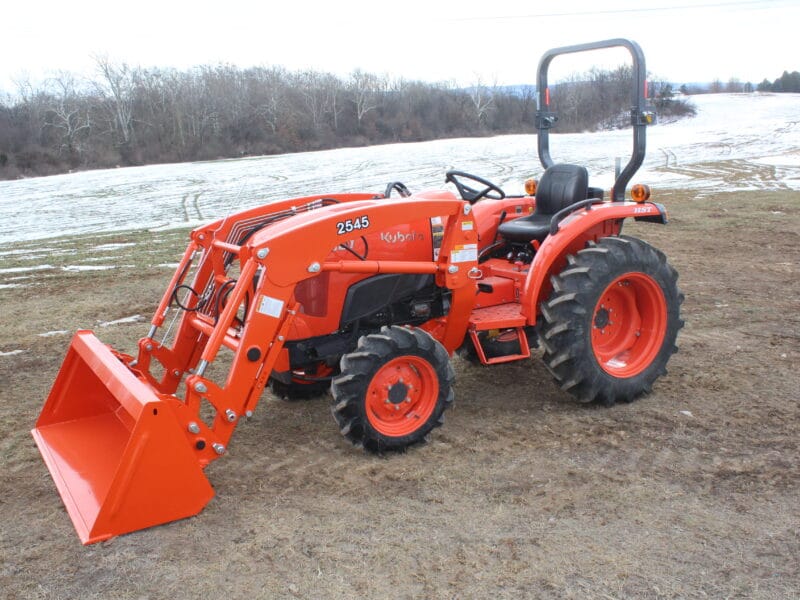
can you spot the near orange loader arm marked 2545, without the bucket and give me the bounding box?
[170,199,477,464]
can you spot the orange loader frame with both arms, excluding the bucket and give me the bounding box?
[138,195,477,465]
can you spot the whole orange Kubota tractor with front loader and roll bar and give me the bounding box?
[33,40,683,544]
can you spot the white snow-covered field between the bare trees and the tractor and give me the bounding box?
[0,94,800,245]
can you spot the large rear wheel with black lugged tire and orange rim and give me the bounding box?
[539,236,683,406]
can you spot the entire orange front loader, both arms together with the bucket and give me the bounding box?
[33,194,478,544]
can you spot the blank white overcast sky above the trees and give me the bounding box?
[0,0,800,92]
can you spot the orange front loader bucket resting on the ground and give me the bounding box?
[31,331,214,544]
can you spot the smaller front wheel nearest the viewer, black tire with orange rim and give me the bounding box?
[331,326,455,453]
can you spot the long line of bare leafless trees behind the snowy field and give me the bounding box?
[0,57,692,179]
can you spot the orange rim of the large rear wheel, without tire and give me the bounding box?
[592,273,667,377]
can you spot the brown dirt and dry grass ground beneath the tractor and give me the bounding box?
[0,191,800,600]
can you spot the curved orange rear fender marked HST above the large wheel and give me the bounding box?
[522,202,667,325]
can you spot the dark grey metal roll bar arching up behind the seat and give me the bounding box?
[536,38,655,202]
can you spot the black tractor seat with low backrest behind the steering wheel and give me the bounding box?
[497,164,589,243]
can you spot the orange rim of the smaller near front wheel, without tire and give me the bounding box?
[366,356,439,437]
